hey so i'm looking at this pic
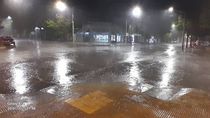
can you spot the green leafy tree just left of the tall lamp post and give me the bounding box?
[45,18,71,40]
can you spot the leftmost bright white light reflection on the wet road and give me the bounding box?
[11,64,29,94]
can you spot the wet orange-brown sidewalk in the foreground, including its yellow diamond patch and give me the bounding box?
[0,84,210,118]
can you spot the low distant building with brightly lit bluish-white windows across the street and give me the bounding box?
[76,22,124,43]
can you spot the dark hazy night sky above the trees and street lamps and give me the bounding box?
[0,0,207,33]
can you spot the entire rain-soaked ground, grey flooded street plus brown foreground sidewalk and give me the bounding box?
[0,40,210,118]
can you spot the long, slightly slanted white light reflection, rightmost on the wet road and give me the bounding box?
[159,45,175,88]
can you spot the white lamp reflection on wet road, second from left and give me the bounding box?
[55,56,74,85]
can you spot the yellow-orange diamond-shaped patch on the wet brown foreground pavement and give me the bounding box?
[66,91,113,114]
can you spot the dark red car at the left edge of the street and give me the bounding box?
[0,36,15,47]
